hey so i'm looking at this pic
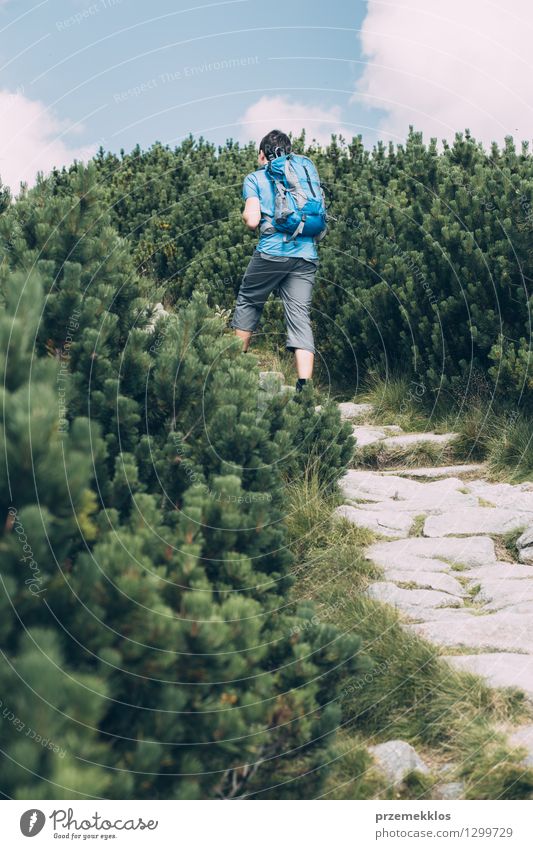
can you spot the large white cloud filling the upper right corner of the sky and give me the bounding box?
[353,0,533,144]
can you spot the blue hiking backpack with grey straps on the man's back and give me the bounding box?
[261,153,327,242]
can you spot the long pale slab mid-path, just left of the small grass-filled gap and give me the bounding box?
[366,536,497,571]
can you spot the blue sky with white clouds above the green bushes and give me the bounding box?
[0,0,533,193]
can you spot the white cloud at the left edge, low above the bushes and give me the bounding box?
[0,89,96,194]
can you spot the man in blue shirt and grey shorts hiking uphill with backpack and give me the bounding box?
[231,130,326,392]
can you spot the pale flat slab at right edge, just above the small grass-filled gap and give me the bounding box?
[424,507,533,537]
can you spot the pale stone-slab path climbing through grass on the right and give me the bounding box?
[336,404,533,776]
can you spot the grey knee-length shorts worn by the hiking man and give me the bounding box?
[231,250,318,353]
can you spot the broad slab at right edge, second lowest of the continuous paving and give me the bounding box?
[407,610,533,654]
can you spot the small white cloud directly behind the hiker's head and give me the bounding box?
[237,97,353,144]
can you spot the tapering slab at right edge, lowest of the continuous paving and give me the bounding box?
[444,652,533,700]
